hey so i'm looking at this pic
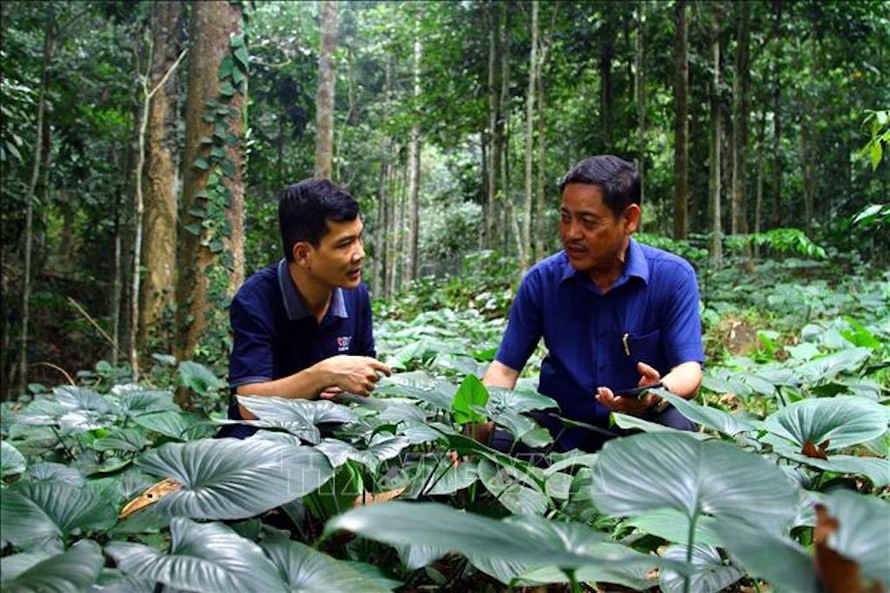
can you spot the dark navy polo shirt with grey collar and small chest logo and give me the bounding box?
[229,259,376,398]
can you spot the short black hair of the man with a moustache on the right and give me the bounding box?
[559,154,640,217]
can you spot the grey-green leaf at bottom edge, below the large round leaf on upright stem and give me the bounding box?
[714,517,820,593]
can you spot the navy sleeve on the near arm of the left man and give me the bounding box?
[229,294,275,389]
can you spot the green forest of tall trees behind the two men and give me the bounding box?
[0,0,890,399]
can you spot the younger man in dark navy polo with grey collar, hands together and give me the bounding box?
[221,179,391,438]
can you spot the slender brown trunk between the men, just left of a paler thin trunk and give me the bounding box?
[482,2,504,249]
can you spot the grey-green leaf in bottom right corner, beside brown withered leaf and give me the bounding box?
[825,490,890,589]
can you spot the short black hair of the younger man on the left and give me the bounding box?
[278,178,359,261]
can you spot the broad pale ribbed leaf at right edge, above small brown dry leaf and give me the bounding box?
[764,396,890,451]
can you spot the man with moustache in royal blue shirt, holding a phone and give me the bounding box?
[483,156,704,451]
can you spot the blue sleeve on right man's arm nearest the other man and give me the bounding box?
[495,270,543,372]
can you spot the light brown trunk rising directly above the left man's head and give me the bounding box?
[315,0,337,179]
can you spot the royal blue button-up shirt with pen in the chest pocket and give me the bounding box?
[495,239,704,450]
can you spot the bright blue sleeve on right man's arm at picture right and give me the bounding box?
[662,262,705,368]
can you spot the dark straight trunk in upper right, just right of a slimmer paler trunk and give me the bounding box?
[731,2,751,240]
